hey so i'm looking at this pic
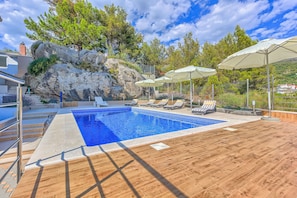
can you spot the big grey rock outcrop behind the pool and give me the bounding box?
[27,42,143,101]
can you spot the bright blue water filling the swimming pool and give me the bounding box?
[72,107,224,146]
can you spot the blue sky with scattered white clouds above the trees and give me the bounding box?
[0,0,297,50]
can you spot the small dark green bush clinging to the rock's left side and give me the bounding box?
[28,55,58,76]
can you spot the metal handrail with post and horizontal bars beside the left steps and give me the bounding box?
[0,71,25,183]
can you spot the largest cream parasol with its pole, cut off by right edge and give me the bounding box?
[218,36,297,117]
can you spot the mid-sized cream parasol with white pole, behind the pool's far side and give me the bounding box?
[165,65,217,108]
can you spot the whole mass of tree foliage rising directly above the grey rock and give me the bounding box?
[24,0,143,61]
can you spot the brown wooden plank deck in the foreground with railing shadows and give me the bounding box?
[12,120,297,198]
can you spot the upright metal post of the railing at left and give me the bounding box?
[17,84,23,182]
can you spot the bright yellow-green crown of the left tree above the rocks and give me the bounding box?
[24,0,105,50]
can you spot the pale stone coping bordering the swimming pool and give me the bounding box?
[25,107,260,170]
